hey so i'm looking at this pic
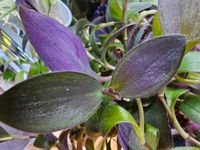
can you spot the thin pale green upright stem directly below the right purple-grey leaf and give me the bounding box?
[136,98,144,133]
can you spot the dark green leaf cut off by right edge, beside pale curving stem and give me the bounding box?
[179,95,200,124]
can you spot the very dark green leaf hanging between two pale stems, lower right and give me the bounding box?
[144,97,173,149]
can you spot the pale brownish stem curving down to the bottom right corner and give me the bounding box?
[159,92,200,146]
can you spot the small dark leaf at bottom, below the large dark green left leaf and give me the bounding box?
[33,134,53,149]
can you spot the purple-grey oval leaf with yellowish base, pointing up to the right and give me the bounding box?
[110,35,186,98]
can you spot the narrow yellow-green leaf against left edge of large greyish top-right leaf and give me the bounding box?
[152,13,163,37]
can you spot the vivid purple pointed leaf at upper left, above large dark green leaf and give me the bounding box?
[19,7,96,76]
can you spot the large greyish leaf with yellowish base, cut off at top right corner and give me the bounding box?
[158,0,200,50]
